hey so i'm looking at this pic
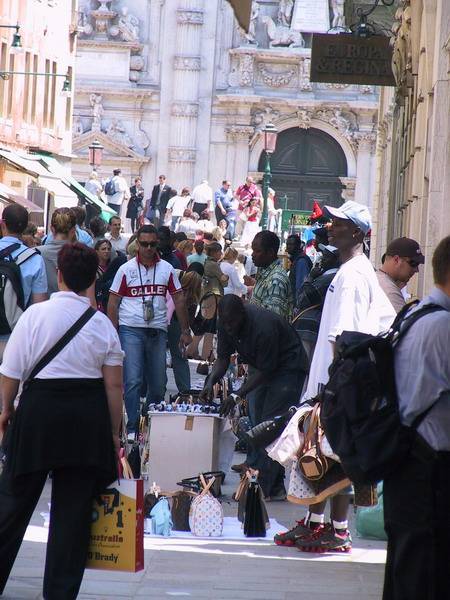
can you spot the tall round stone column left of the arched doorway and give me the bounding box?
[168,0,204,188]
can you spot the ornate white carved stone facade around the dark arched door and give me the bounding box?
[73,0,378,212]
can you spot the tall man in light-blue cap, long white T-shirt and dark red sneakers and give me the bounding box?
[275,200,395,552]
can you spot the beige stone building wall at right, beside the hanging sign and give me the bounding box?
[372,0,450,296]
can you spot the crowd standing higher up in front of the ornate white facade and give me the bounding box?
[85,169,281,248]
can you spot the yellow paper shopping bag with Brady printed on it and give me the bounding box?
[86,459,144,573]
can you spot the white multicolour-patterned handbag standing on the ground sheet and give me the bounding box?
[189,475,223,537]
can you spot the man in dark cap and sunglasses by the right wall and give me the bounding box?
[377,237,425,313]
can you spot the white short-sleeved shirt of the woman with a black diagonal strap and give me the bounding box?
[0,292,123,380]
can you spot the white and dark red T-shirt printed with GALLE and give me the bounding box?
[110,258,181,331]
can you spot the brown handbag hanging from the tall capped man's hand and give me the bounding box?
[297,403,334,481]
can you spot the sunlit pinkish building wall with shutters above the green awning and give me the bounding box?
[0,0,76,154]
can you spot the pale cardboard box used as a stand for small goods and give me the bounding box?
[145,413,222,492]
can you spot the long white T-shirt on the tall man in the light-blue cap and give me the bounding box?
[303,254,396,400]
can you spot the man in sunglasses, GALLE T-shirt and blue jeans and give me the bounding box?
[108,225,192,439]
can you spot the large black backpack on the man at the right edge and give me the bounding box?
[320,304,444,484]
